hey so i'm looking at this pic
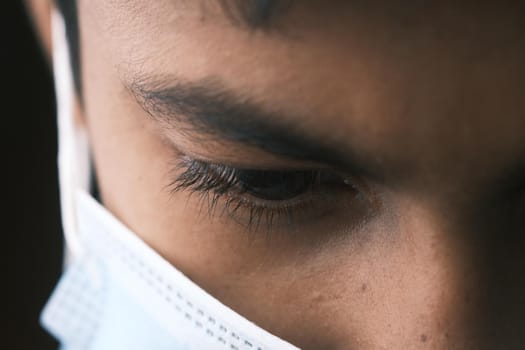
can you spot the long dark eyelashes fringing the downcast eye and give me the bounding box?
[169,157,355,232]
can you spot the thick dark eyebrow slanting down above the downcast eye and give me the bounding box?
[124,75,379,177]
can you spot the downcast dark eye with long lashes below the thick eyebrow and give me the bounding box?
[171,158,359,234]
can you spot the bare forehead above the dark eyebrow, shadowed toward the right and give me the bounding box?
[80,0,525,186]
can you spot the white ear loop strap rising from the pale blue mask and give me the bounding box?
[51,8,90,264]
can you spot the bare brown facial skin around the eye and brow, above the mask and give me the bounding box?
[27,0,525,349]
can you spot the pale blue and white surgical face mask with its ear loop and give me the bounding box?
[41,8,297,350]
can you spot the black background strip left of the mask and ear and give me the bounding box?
[0,0,62,350]
